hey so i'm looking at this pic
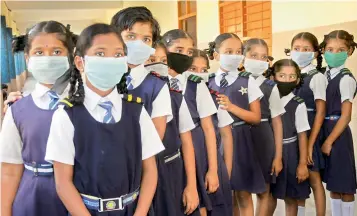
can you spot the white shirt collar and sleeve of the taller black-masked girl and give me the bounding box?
[169,72,217,118]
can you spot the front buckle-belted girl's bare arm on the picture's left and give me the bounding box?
[53,162,90,216]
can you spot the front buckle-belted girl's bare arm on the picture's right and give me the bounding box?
[134,156,158,216]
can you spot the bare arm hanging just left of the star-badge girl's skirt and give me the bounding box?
[219,125,233,178]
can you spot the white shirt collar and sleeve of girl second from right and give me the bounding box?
[301,64,328,101]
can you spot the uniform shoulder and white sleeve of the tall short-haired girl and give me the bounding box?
[126,64,172,122]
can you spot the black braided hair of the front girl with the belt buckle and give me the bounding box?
[68,23,127,104]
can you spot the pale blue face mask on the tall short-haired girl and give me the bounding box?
[125,40,155,65]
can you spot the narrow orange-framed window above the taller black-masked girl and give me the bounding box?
[177,0,197,45]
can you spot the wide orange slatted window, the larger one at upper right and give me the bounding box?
[219,0,272,54]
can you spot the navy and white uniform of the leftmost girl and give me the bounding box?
[0,83,67,216]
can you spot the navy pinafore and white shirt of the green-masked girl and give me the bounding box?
[323,65,357,194]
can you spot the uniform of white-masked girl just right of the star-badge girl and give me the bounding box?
[251,76,285,184]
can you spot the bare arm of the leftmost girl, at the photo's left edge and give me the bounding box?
[1,163,24,216]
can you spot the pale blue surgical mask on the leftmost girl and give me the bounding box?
[27,56,69,85]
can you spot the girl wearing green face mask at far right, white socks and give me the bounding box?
[320,30,357,216]
